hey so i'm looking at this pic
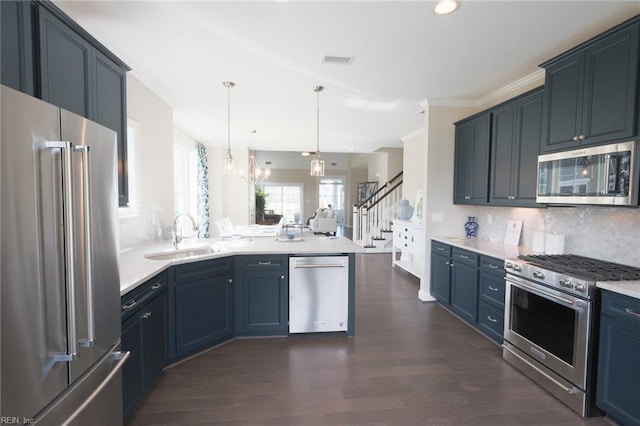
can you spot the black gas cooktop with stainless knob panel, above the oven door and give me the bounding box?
[505,254,640,299]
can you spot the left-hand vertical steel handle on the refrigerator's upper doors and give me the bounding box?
[45,141,78,362]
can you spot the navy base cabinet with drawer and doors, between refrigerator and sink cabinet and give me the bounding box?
[121,273,167,418]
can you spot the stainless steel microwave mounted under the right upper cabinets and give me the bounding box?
[536,141,638,206]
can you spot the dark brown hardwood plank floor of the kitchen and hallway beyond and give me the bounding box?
[131,254,611,426]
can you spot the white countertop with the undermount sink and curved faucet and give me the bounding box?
[120,235,364,295]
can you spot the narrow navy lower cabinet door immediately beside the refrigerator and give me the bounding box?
[121,312,144,418]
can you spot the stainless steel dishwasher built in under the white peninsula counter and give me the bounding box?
[289,256,349,333]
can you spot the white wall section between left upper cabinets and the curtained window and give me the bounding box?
[119,73,173,249]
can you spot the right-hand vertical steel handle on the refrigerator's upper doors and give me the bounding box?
[73,145,96,348]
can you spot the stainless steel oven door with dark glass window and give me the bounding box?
[504,274,592,390]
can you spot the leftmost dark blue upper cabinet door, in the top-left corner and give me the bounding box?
[0,1,35,96]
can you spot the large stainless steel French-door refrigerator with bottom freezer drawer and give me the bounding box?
[0,86,128,426]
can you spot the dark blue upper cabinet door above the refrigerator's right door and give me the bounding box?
[38,7,93,118]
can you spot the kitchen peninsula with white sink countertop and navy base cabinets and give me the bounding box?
[120,236,362,418]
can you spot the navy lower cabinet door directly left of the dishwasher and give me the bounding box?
[239,271,289,335]
